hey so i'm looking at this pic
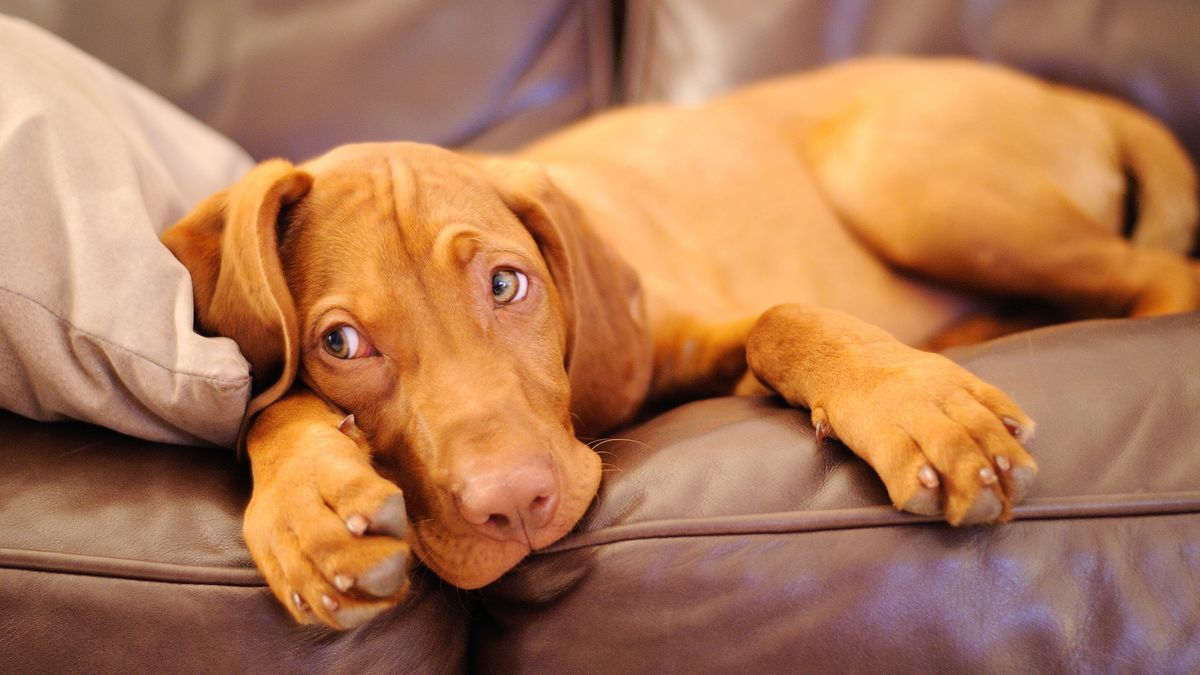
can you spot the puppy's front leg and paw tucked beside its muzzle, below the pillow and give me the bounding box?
[242,390,409,628]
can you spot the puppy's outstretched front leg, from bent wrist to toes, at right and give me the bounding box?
[746,305,1037,525]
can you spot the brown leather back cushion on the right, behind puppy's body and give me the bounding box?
[622,0,1200,165]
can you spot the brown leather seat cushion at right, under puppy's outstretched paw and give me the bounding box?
[473,313,1200,673]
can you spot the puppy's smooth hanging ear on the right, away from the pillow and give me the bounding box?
[482,159,653,436]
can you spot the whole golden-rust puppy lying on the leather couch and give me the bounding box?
[164,60,1200,627]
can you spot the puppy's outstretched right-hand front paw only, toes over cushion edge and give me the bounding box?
[812,344,1038,525]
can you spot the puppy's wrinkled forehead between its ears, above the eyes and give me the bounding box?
[281,143,532,293]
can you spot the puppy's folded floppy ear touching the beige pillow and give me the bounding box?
[162,160,312,431]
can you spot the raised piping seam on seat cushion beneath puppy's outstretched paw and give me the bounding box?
[534,491,1200,555]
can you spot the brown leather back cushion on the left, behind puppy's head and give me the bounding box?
[0,0,613,161]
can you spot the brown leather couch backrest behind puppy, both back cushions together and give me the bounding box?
[0,0,1200,160]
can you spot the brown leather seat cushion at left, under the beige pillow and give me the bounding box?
[0,412,468,673]
